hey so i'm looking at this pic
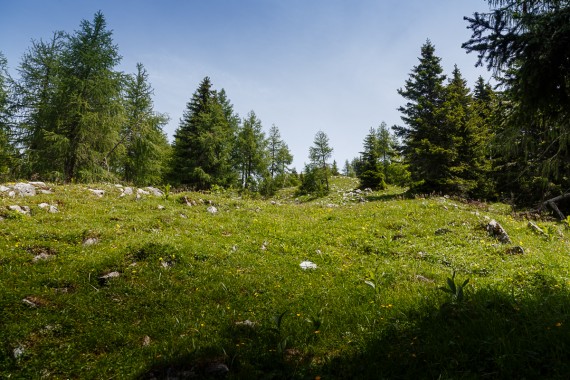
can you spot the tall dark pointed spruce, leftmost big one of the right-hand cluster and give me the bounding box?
[395,40,455,192]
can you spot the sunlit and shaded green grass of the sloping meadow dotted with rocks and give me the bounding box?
[0,178,570,379]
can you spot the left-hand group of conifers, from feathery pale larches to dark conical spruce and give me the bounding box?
[0,12,297,193]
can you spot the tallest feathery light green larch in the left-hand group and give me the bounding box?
[58,12,123,181]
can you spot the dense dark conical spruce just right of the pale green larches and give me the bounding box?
[170,77,235,190]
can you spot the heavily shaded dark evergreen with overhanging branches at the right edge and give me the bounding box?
[463,0,570,203]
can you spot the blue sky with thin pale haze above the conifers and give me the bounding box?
[0,0,491,171]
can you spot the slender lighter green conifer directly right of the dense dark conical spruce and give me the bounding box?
[237,111,269,190]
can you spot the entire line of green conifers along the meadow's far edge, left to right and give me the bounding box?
[0,0,570,208]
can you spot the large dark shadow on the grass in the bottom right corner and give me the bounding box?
[322,288,570,379]
